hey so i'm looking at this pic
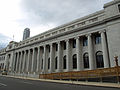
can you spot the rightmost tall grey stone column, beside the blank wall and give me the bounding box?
[101,31,110,68]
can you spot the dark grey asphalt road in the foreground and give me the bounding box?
[0,76,119,90]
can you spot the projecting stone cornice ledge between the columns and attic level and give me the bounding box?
[8,15,120,51]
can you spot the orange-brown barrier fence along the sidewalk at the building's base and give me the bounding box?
[39,66,120,82]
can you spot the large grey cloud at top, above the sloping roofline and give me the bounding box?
[21,0,109,25]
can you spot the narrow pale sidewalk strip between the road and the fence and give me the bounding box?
[2,75,120,88]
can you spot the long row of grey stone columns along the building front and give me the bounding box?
[12,31,109,74]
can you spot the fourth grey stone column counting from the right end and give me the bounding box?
[66,40,72,72]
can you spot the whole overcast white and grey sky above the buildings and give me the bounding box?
[0,0,112,43]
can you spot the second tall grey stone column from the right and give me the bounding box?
[88,34,95,70]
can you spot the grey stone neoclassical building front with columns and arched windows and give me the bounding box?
[0,0,120,76]
